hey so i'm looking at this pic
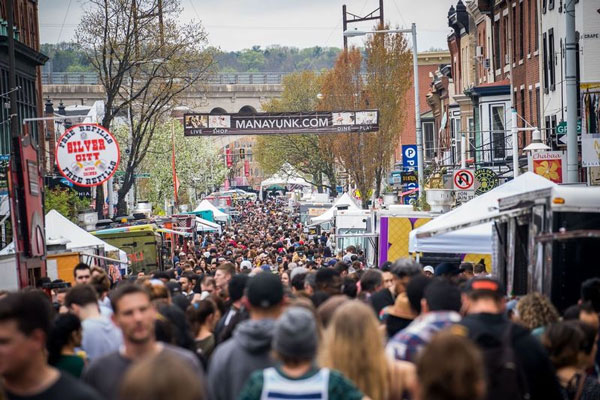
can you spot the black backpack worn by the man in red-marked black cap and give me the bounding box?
[473,323,530,400]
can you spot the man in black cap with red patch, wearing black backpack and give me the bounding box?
[460,277,561,400]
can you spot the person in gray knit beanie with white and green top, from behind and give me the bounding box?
[238,307,364,400]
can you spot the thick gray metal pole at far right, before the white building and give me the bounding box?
[564,0,579,183]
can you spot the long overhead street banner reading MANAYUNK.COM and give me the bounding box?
[183,110,379,136]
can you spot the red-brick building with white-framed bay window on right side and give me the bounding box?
[427,0,543,176]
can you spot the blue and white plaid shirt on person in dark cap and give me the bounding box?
[385,311,460,362]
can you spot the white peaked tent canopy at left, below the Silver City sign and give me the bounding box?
[0,210,127,260]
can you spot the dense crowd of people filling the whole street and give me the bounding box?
[0,200,600,400]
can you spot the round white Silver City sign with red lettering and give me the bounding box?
[56,124,121,187]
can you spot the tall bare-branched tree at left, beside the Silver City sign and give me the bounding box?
[77,0,212,214]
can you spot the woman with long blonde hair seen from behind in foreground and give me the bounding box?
[319,300,415,400]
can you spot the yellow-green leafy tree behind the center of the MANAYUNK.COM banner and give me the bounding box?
[255,71,336,192]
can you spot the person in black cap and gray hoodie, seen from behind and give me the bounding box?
[208,272,284,400]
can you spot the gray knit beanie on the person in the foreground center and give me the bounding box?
[273,307,317,360]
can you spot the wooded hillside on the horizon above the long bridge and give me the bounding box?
[41,42,340,73]
